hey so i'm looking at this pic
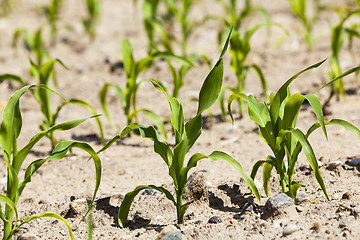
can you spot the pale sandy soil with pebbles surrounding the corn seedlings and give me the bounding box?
[0,0,360,239]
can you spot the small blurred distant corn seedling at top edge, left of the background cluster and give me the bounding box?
[82,0,101,40]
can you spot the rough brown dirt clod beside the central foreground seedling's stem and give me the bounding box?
[184,171,209,203]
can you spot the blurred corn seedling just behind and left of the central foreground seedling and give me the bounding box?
[100,39,192,136]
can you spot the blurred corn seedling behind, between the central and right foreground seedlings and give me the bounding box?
[219,23,281,118]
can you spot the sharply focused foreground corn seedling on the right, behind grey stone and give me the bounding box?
[228,60,360,199]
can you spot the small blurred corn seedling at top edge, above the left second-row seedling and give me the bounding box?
[42,0,63,44]
